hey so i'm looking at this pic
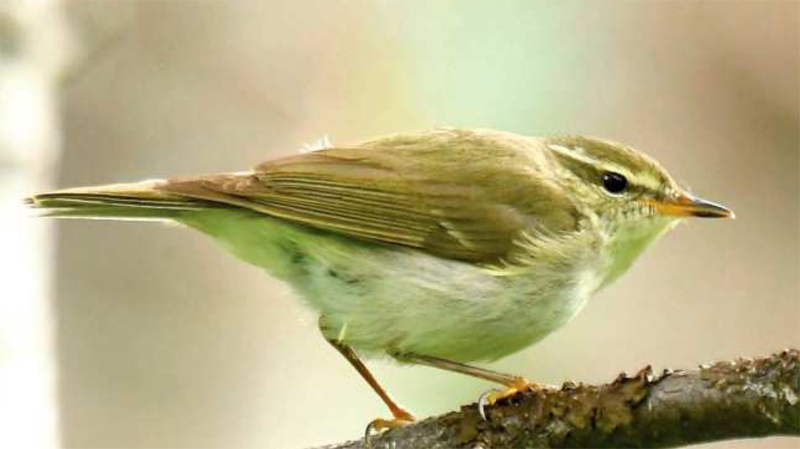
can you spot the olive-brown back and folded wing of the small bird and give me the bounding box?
[158,131,569,262]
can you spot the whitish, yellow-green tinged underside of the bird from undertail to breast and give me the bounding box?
[180,211,594,362]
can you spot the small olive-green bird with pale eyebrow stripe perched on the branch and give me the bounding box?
[25,128,734,435]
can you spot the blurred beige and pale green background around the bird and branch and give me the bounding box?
[0,0,800,448]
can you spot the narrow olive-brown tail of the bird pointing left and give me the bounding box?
[25,181,215,220]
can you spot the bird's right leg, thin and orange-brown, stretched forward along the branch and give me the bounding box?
[393,354,544,419]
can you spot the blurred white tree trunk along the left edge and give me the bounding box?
[0,0,73,448]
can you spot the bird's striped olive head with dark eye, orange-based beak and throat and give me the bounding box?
[547,137,734,285]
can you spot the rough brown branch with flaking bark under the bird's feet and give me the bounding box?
[317,349,800,449]
